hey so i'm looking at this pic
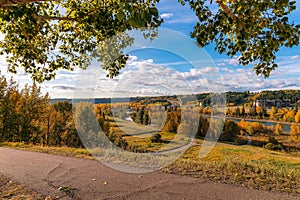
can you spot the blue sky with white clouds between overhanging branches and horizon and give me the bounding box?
[0,0,300,98]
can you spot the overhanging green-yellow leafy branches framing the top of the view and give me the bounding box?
[0,0,300,82]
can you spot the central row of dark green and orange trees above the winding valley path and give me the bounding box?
[130,105,241,142]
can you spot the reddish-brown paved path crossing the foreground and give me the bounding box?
[0,148,299,200]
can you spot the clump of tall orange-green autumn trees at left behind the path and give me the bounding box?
[0,76,83,147]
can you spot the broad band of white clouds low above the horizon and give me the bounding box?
[0,49,300,98]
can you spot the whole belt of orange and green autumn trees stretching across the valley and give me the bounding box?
[0,72,300,150]
